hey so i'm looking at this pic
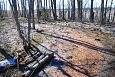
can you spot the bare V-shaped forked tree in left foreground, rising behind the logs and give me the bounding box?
[9,0,32,53]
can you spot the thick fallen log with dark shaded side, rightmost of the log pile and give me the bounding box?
[24,53,54,77]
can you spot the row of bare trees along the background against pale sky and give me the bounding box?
[0,0,115,24]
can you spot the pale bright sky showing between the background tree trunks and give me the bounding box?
[0,0,115,10]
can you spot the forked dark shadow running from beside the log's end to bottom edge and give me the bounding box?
[33,39,93,77]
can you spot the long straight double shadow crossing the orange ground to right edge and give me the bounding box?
[37,30,115,56]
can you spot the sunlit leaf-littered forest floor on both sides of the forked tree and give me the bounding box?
[0,19,115,77]
